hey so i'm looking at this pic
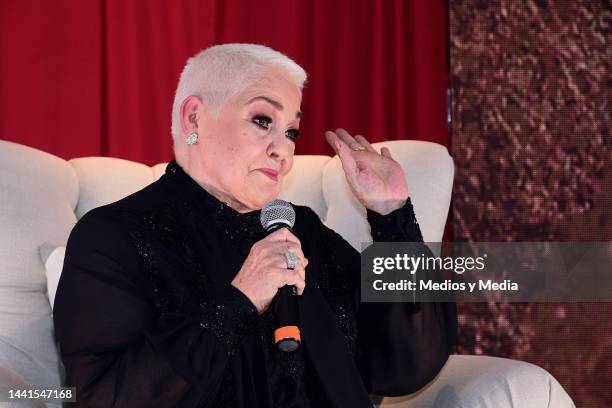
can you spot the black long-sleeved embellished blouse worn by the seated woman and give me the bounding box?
[54,161,456,408]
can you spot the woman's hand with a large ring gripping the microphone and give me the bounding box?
[232,228,308,314]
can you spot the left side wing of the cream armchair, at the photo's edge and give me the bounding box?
[0,142,71,402]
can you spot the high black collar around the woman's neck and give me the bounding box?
[166,160,264,240]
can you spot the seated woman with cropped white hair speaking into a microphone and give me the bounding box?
[54,44,456,408]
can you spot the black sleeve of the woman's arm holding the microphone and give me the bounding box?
[54,210,257,407]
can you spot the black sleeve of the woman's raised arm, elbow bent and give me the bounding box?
[357,199,457,396]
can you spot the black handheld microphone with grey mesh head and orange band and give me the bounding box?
[260,200,301,351]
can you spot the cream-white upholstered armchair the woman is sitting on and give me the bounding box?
[0,141,573,408]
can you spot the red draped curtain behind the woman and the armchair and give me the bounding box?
[0,0,447,164]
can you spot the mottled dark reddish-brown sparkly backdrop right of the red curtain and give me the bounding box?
[449,0,612,408]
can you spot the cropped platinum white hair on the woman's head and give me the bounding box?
[171,44,307,142]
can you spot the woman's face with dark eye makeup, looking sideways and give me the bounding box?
[193,69,302,212]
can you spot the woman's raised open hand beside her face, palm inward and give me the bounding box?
[325,129,408,215]
